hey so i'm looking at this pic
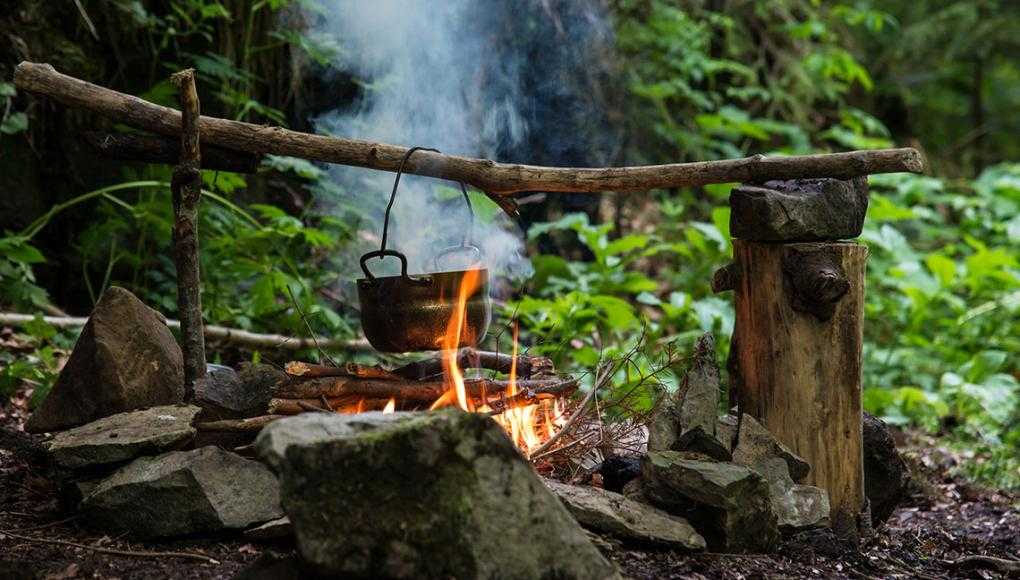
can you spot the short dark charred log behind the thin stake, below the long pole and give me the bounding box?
[82,131,262,173]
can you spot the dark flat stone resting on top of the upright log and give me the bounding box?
[729,177,868,242]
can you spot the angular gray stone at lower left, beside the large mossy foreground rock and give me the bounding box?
[82,446,284,538]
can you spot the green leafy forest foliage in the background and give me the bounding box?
[0,0,1020,488]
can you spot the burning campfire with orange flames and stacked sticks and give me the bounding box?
[267,268,578,456]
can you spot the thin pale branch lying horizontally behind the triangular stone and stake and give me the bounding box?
[0,312,370,352]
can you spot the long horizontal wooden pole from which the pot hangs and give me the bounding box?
[14,62,924,194]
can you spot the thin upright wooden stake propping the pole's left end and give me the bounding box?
[170,68,205,391]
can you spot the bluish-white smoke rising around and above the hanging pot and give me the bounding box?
[315,0,610,285]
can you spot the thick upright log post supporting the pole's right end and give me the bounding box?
[730,240,870,536]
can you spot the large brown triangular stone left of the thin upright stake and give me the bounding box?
[24,286,185,433]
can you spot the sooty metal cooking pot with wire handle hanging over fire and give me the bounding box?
[358,147,492,353]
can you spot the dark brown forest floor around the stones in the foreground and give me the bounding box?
[0,379,1020,580]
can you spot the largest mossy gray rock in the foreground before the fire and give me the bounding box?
[256,410,616,579]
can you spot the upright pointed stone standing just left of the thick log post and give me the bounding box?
[648,332,719,452]
